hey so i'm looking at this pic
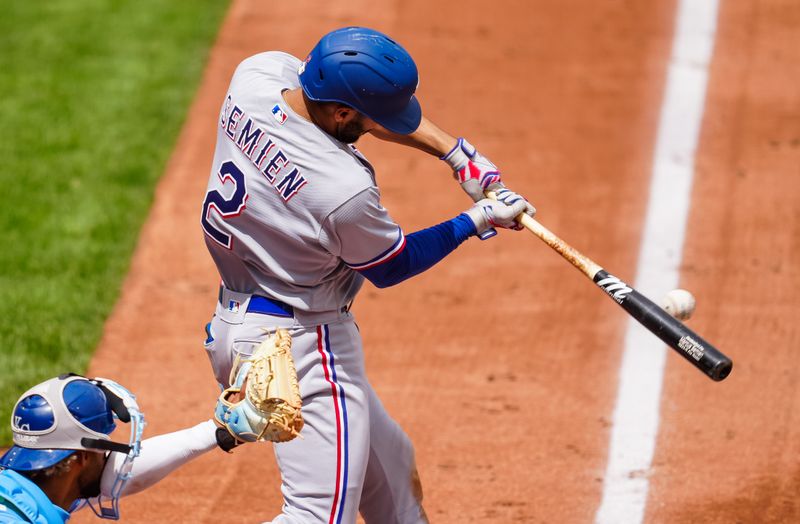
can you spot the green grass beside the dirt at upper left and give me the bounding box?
[0,0,228,444]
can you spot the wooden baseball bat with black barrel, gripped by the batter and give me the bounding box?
[487,192,733,382]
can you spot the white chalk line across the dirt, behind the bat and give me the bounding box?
[595,0,718,524]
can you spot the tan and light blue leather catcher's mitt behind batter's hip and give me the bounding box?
[214,329,303,442]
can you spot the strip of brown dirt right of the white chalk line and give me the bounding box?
[648,0,800,523]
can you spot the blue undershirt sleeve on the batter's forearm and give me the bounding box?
[359,213,476,288]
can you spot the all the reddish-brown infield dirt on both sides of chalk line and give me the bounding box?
[76,0,800,523]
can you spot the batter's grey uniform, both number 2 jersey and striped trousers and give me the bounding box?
[202,52,427,524]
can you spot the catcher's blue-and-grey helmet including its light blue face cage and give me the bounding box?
[0,374,145,520]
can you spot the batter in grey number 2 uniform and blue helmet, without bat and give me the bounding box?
[201,27,535,524]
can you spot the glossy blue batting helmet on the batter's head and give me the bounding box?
[299,27,422,135]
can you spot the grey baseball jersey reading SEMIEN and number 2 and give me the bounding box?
[201,52,405,311]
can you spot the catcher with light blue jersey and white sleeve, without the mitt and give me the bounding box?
[0,374,244,524]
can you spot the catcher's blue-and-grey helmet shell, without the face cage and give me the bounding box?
[0,376,116,471]
